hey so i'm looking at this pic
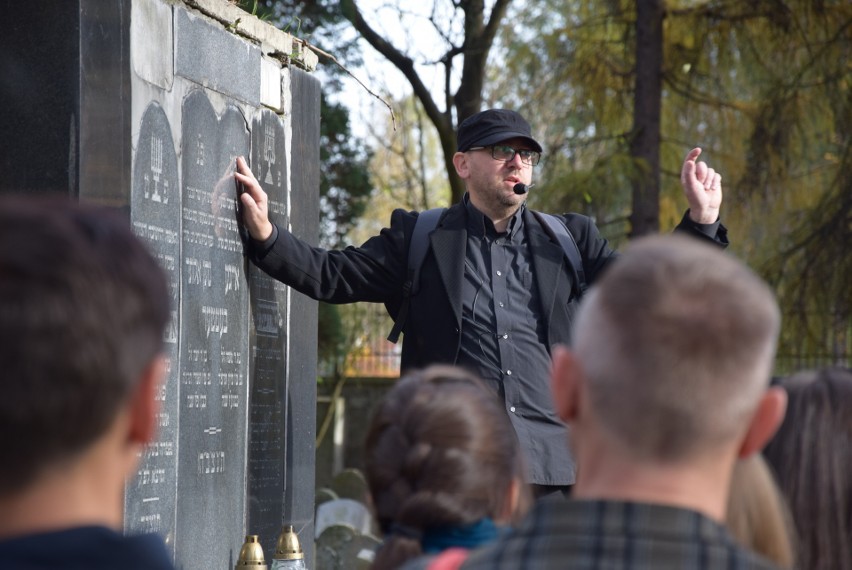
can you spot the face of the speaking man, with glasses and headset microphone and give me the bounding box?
[459,138,533,213]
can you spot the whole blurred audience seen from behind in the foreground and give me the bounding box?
[0,192,852,570]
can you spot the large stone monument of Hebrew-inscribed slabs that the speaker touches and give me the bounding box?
[0,0,320,568]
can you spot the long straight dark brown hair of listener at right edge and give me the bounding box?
[764,368,852,570]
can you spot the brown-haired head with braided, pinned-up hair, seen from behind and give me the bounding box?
[366,366,526,569]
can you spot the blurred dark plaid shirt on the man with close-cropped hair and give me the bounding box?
[462,500,776,570]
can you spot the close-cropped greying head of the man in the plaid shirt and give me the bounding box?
[554,235,783,516]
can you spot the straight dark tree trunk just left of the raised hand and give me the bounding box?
[630,0,663,237]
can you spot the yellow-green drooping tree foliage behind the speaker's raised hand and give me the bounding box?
[490,0,852,362]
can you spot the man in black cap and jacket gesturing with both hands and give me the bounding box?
[236,109,727,495]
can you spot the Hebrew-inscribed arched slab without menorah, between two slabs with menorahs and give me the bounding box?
[176,90,249,568]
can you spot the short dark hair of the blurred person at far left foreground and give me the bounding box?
[0,196,170,497]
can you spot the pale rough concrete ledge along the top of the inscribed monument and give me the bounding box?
[183,0,318,71]
